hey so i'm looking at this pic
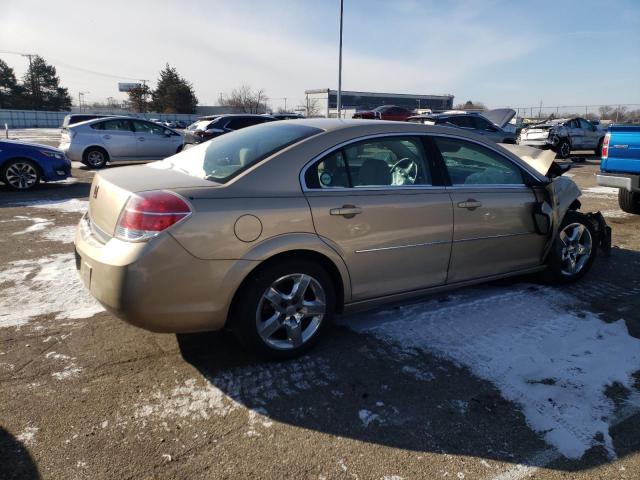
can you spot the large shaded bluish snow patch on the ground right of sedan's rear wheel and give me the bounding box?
[348,288,640,458]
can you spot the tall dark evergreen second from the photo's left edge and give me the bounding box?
[22,55,71,110]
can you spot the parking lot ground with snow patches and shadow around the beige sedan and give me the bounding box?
[0,129,640,480]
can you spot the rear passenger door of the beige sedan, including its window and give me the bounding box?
[304,136,453,301]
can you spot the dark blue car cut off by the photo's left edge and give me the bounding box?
[0,140,71,190]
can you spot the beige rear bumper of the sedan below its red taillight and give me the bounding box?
[75,215,255,333]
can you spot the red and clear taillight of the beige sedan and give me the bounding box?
[116,191,191,241]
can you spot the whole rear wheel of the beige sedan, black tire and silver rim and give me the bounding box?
[231,260,336,359]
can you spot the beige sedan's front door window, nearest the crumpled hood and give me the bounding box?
[435,137,524,185]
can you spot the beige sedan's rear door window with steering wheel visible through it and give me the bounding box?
[305,137,432,189]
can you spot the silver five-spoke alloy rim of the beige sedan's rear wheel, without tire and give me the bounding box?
[256,273,327,350]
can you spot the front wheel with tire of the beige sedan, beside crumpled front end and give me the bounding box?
[543,210,598,284]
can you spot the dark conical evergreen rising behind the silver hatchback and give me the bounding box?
[151,63,198,113]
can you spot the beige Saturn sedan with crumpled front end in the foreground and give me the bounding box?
[75,119,606,358]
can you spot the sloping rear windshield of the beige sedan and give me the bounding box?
[163,122,322,183]
